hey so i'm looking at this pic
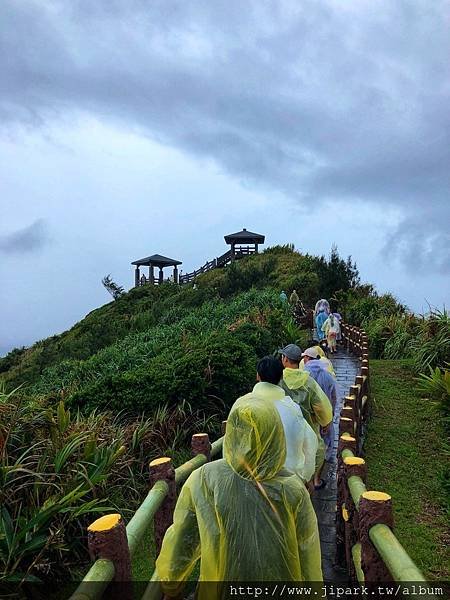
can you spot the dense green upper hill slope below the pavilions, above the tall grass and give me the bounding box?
[0,246,355,411]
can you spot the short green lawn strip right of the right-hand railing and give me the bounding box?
[365,360,450,580]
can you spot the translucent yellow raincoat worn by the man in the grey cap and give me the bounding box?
[280,368,333,471]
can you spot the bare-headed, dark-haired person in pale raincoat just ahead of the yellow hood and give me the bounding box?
[230,356,318,483]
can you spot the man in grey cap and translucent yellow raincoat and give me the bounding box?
[278,344,333,489]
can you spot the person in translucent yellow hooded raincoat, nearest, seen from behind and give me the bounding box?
[156,398,322,600]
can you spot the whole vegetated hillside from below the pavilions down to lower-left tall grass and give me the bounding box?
[0,246,450,584]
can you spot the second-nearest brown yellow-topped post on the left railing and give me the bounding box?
[149,456,177,554]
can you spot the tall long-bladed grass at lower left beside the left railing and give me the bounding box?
[0,382,219,583]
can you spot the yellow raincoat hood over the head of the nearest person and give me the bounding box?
[223,394,286,481]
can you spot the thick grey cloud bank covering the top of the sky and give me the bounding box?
[0,0,450,270]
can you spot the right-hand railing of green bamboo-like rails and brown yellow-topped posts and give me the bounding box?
[336,324,425,585]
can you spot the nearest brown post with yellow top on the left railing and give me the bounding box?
[88,514,133,600]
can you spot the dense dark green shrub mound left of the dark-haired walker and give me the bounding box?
[69,332,257,414]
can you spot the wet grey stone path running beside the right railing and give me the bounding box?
[312,349,359,583]
